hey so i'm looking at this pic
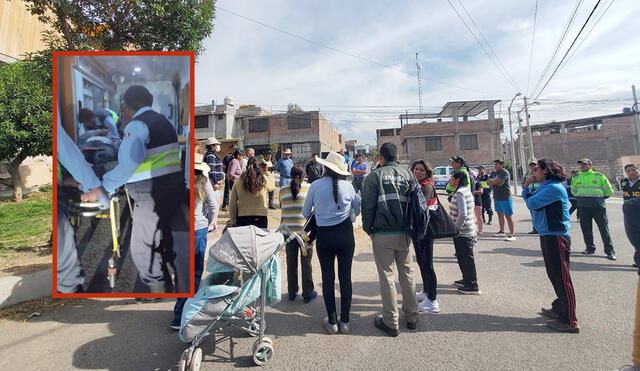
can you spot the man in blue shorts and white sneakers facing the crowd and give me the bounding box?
[487,159,516,241]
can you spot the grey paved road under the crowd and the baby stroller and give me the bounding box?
[0,199,638,370]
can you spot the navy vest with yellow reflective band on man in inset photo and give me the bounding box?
[127,111,182,183]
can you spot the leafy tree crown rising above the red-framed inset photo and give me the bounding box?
[24,0,215,55]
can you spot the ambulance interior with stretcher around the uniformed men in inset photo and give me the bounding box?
[57,55,193,293]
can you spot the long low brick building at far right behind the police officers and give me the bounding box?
[515,112,640,182]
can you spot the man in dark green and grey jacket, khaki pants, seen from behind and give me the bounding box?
[362,143,418,337]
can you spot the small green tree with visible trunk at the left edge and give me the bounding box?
[0,59,52,202]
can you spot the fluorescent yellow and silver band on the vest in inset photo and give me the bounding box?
[127,142,182,183]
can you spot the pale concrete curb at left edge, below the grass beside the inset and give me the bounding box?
[0,268,52,308]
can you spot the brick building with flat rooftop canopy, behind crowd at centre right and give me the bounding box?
[376,100,503,166]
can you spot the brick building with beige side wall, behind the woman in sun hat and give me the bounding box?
[242,111,345,161]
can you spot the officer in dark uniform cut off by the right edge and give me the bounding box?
[620,164,640,268]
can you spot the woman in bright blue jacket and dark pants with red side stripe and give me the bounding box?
[522,158,580,333]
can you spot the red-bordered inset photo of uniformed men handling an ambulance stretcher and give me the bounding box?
[53,52,194,296]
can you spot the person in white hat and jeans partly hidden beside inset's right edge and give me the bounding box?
[169,153,218,330]
